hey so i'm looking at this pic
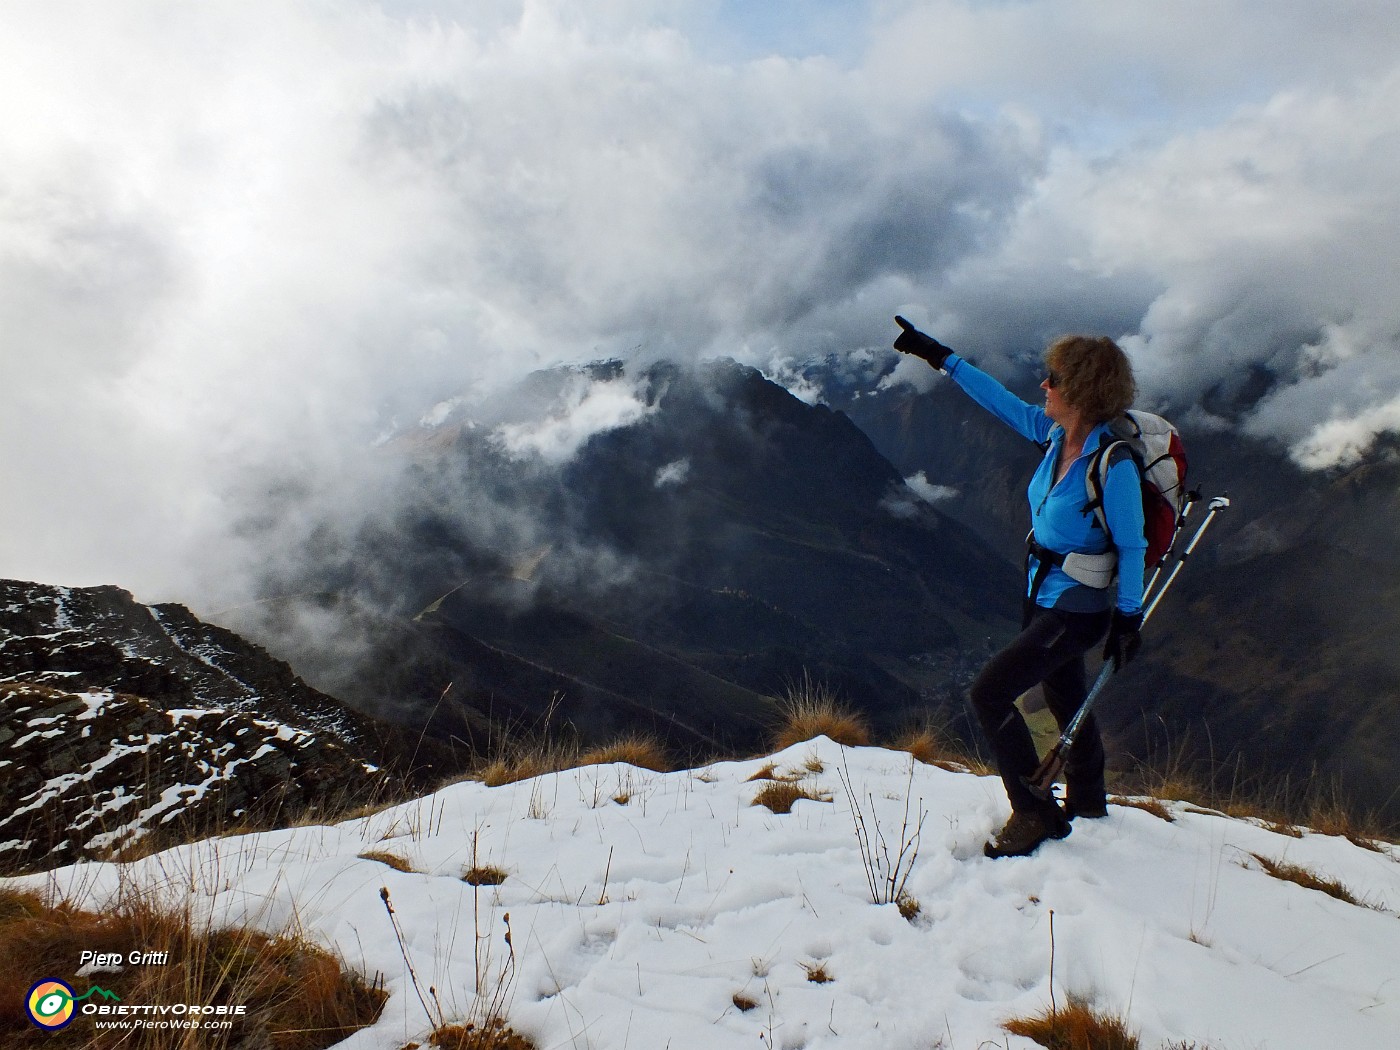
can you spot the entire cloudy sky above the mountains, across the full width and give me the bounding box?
[0,0,1400,603]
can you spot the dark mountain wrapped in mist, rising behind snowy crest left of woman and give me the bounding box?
[221,361,1016,755]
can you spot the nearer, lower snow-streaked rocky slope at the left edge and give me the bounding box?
[0,683,382,869]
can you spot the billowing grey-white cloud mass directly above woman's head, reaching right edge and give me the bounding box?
[893,66,1400,468]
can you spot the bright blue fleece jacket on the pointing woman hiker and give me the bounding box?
[944,354,1147,613]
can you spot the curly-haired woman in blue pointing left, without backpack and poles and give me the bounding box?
[895,318,1147,857]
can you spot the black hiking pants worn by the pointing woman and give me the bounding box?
[972,606,1110,811]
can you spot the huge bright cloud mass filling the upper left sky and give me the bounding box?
[0,0,1039,607]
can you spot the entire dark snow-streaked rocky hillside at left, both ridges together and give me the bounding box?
[0,580,451,871]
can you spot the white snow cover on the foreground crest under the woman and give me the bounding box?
[2,738,1400,1050]
